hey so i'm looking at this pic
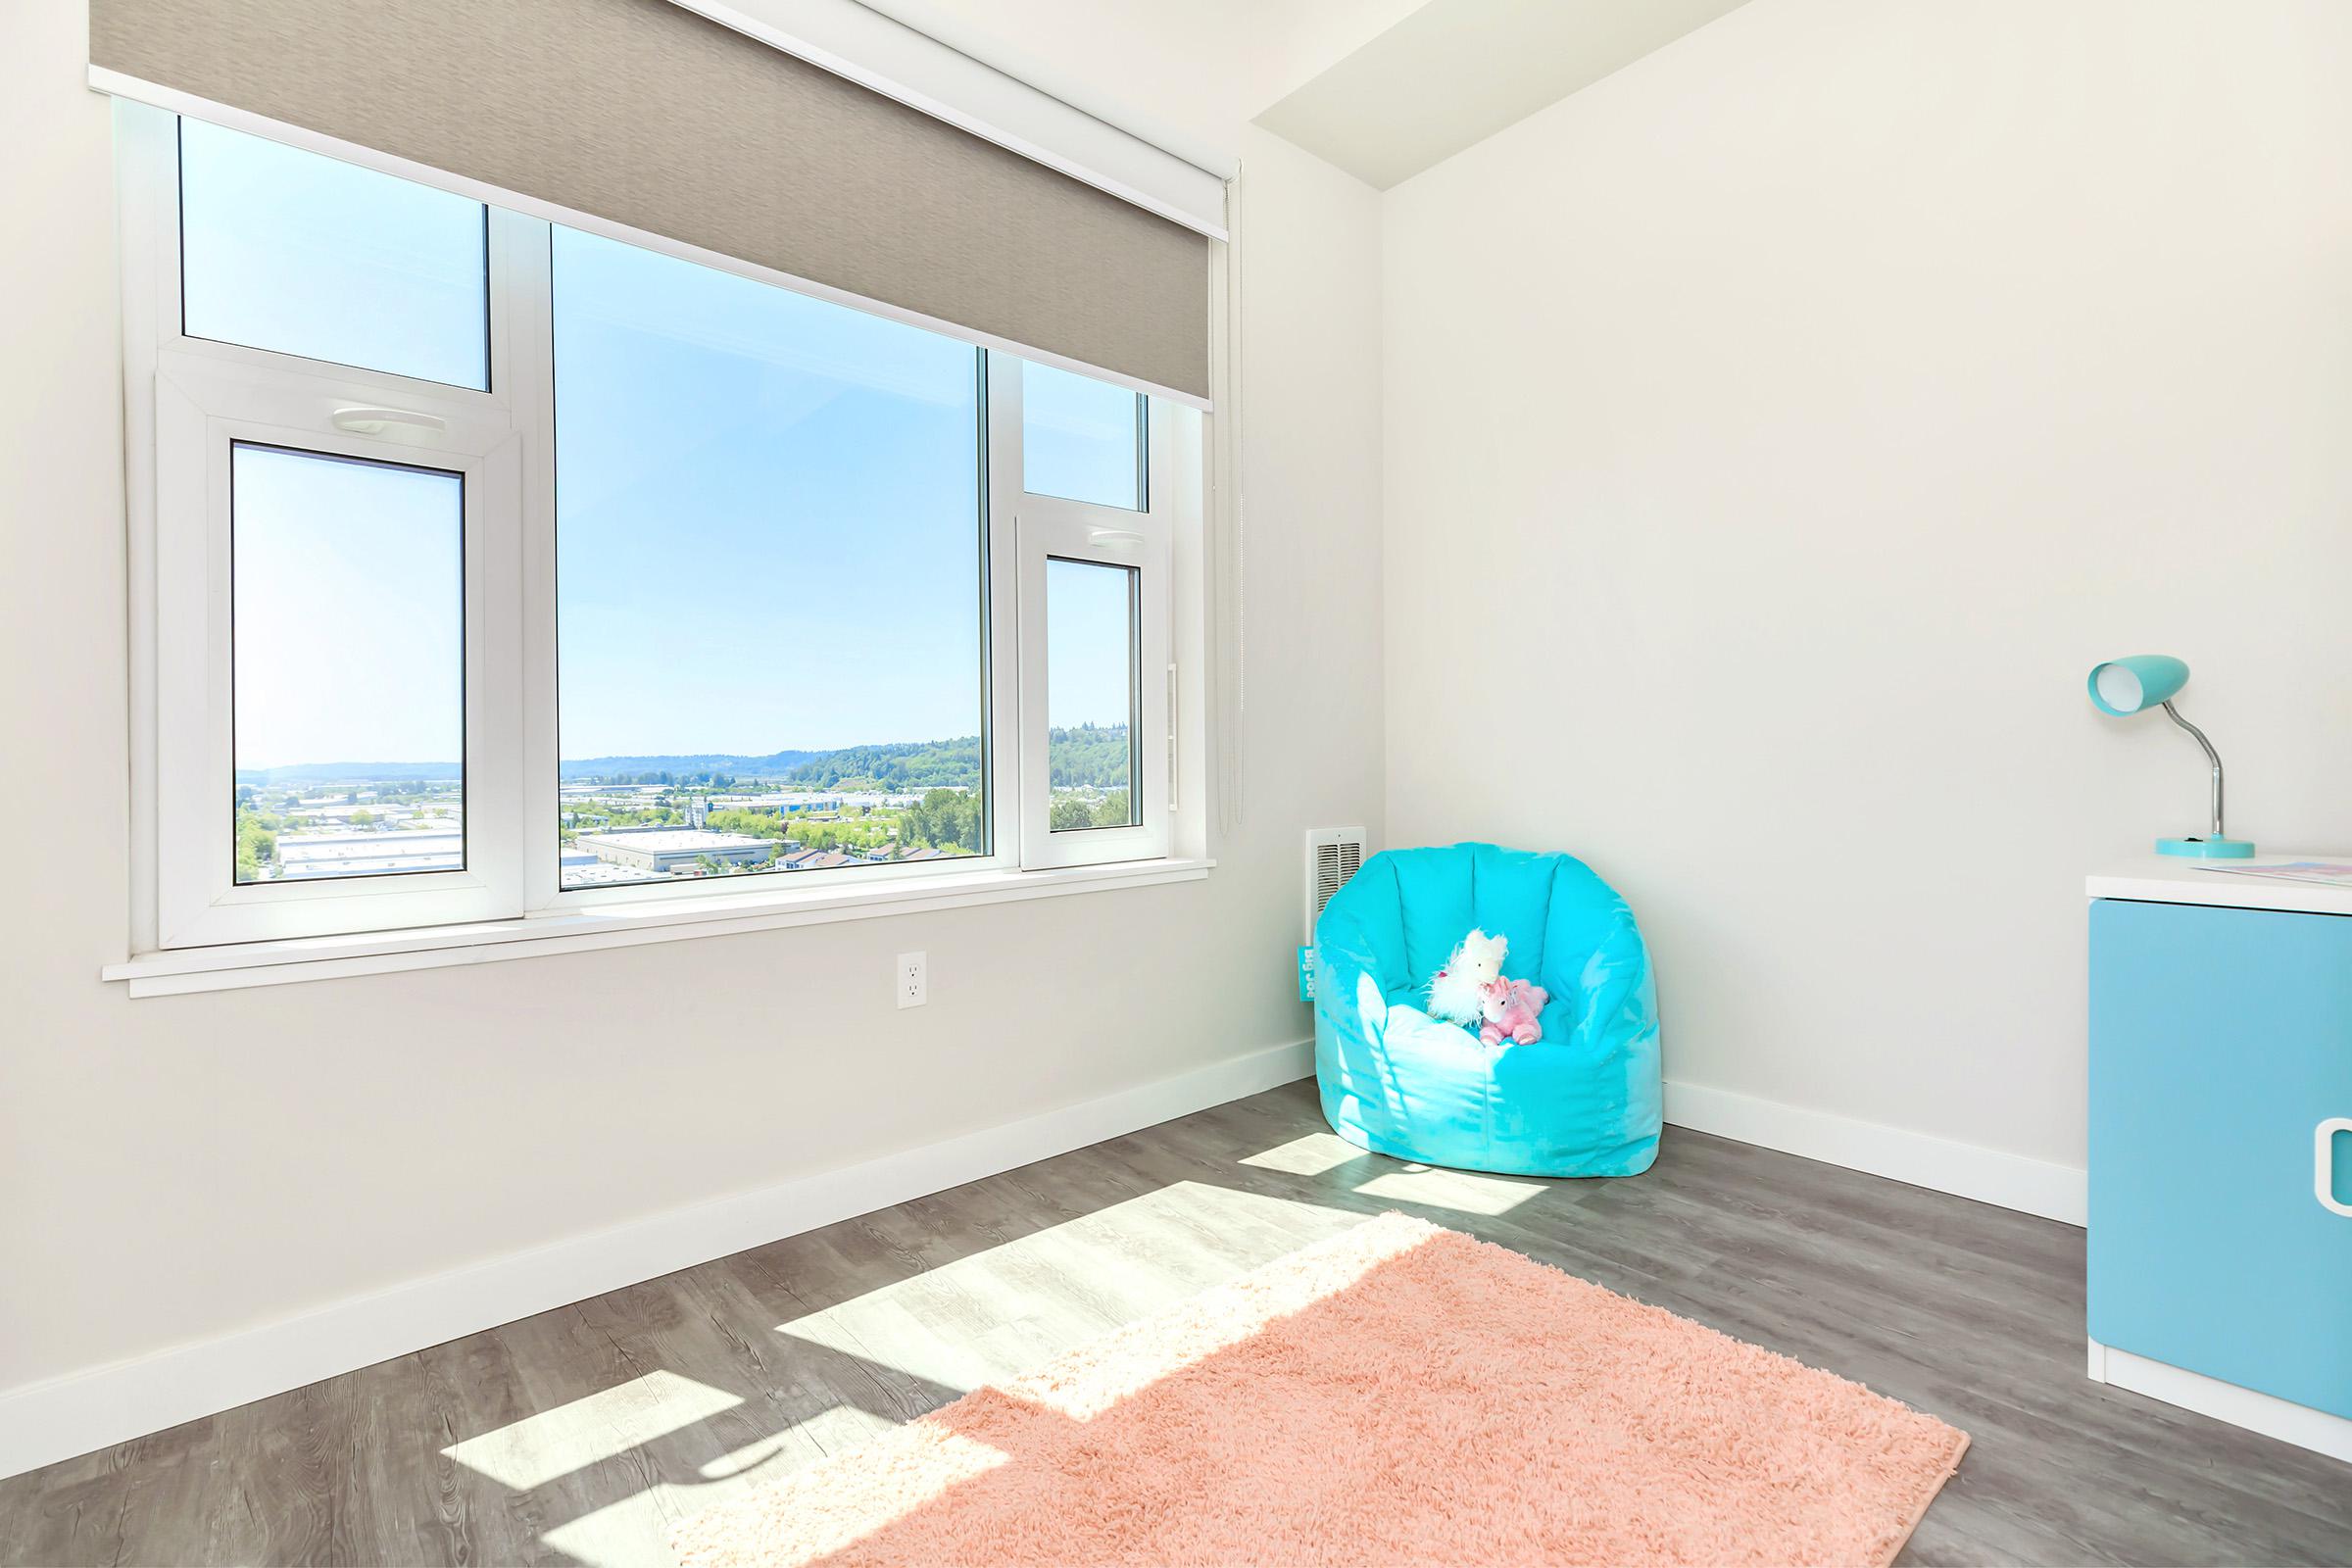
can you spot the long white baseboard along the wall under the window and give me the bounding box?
[0,1042,1315,1476]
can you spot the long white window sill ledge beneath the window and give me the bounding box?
[99,860,1216,997]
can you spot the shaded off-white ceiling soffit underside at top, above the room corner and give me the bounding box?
[1256,0,1742,190]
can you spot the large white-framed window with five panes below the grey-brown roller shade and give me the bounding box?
[122,106,1200,948]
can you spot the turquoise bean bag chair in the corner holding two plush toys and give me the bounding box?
[1315,844,1660,1175]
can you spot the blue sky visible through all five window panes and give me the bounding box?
[202,122,1136,766]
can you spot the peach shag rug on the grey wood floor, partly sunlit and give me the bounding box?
[672,1213,1969,1568]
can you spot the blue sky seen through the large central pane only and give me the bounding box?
[555,228,981,757]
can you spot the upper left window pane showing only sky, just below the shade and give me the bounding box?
[178,120,489,388]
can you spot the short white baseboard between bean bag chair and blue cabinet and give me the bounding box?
[1665,1079,2091,1225]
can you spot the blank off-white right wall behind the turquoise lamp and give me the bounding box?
[1383,0,2352,1163]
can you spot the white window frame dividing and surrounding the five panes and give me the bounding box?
[116,101,1206,963]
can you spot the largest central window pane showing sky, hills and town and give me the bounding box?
[555,228,988,886]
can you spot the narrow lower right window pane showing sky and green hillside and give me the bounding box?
[1045,558,1143,832]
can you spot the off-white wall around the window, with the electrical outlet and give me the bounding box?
[0,5,1381,1392]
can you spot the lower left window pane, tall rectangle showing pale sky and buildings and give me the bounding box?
[230,442,466,882]
